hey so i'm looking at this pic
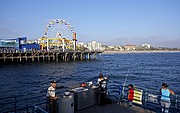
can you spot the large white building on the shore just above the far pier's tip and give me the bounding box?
[87,41,105,51]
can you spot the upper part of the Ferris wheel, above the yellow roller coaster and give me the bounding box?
[45,19,74,39]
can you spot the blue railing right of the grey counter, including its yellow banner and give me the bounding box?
[108,82,180,113]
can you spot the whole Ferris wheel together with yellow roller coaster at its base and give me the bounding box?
[38,19,77,52]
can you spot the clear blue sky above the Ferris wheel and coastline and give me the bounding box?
[0,0,180,47]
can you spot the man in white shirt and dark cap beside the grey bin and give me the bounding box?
[46,80,58,113]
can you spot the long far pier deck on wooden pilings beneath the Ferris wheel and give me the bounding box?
[0,51,102,63]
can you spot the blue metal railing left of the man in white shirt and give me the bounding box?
[0,94,47,113]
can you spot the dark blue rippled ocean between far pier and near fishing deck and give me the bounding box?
[0,52,180,97]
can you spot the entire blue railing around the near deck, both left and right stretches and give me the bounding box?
[0,82,180,113]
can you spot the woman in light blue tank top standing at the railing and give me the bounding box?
[161,83,174,113]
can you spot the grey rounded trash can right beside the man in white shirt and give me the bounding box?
[58,92,74,113]
